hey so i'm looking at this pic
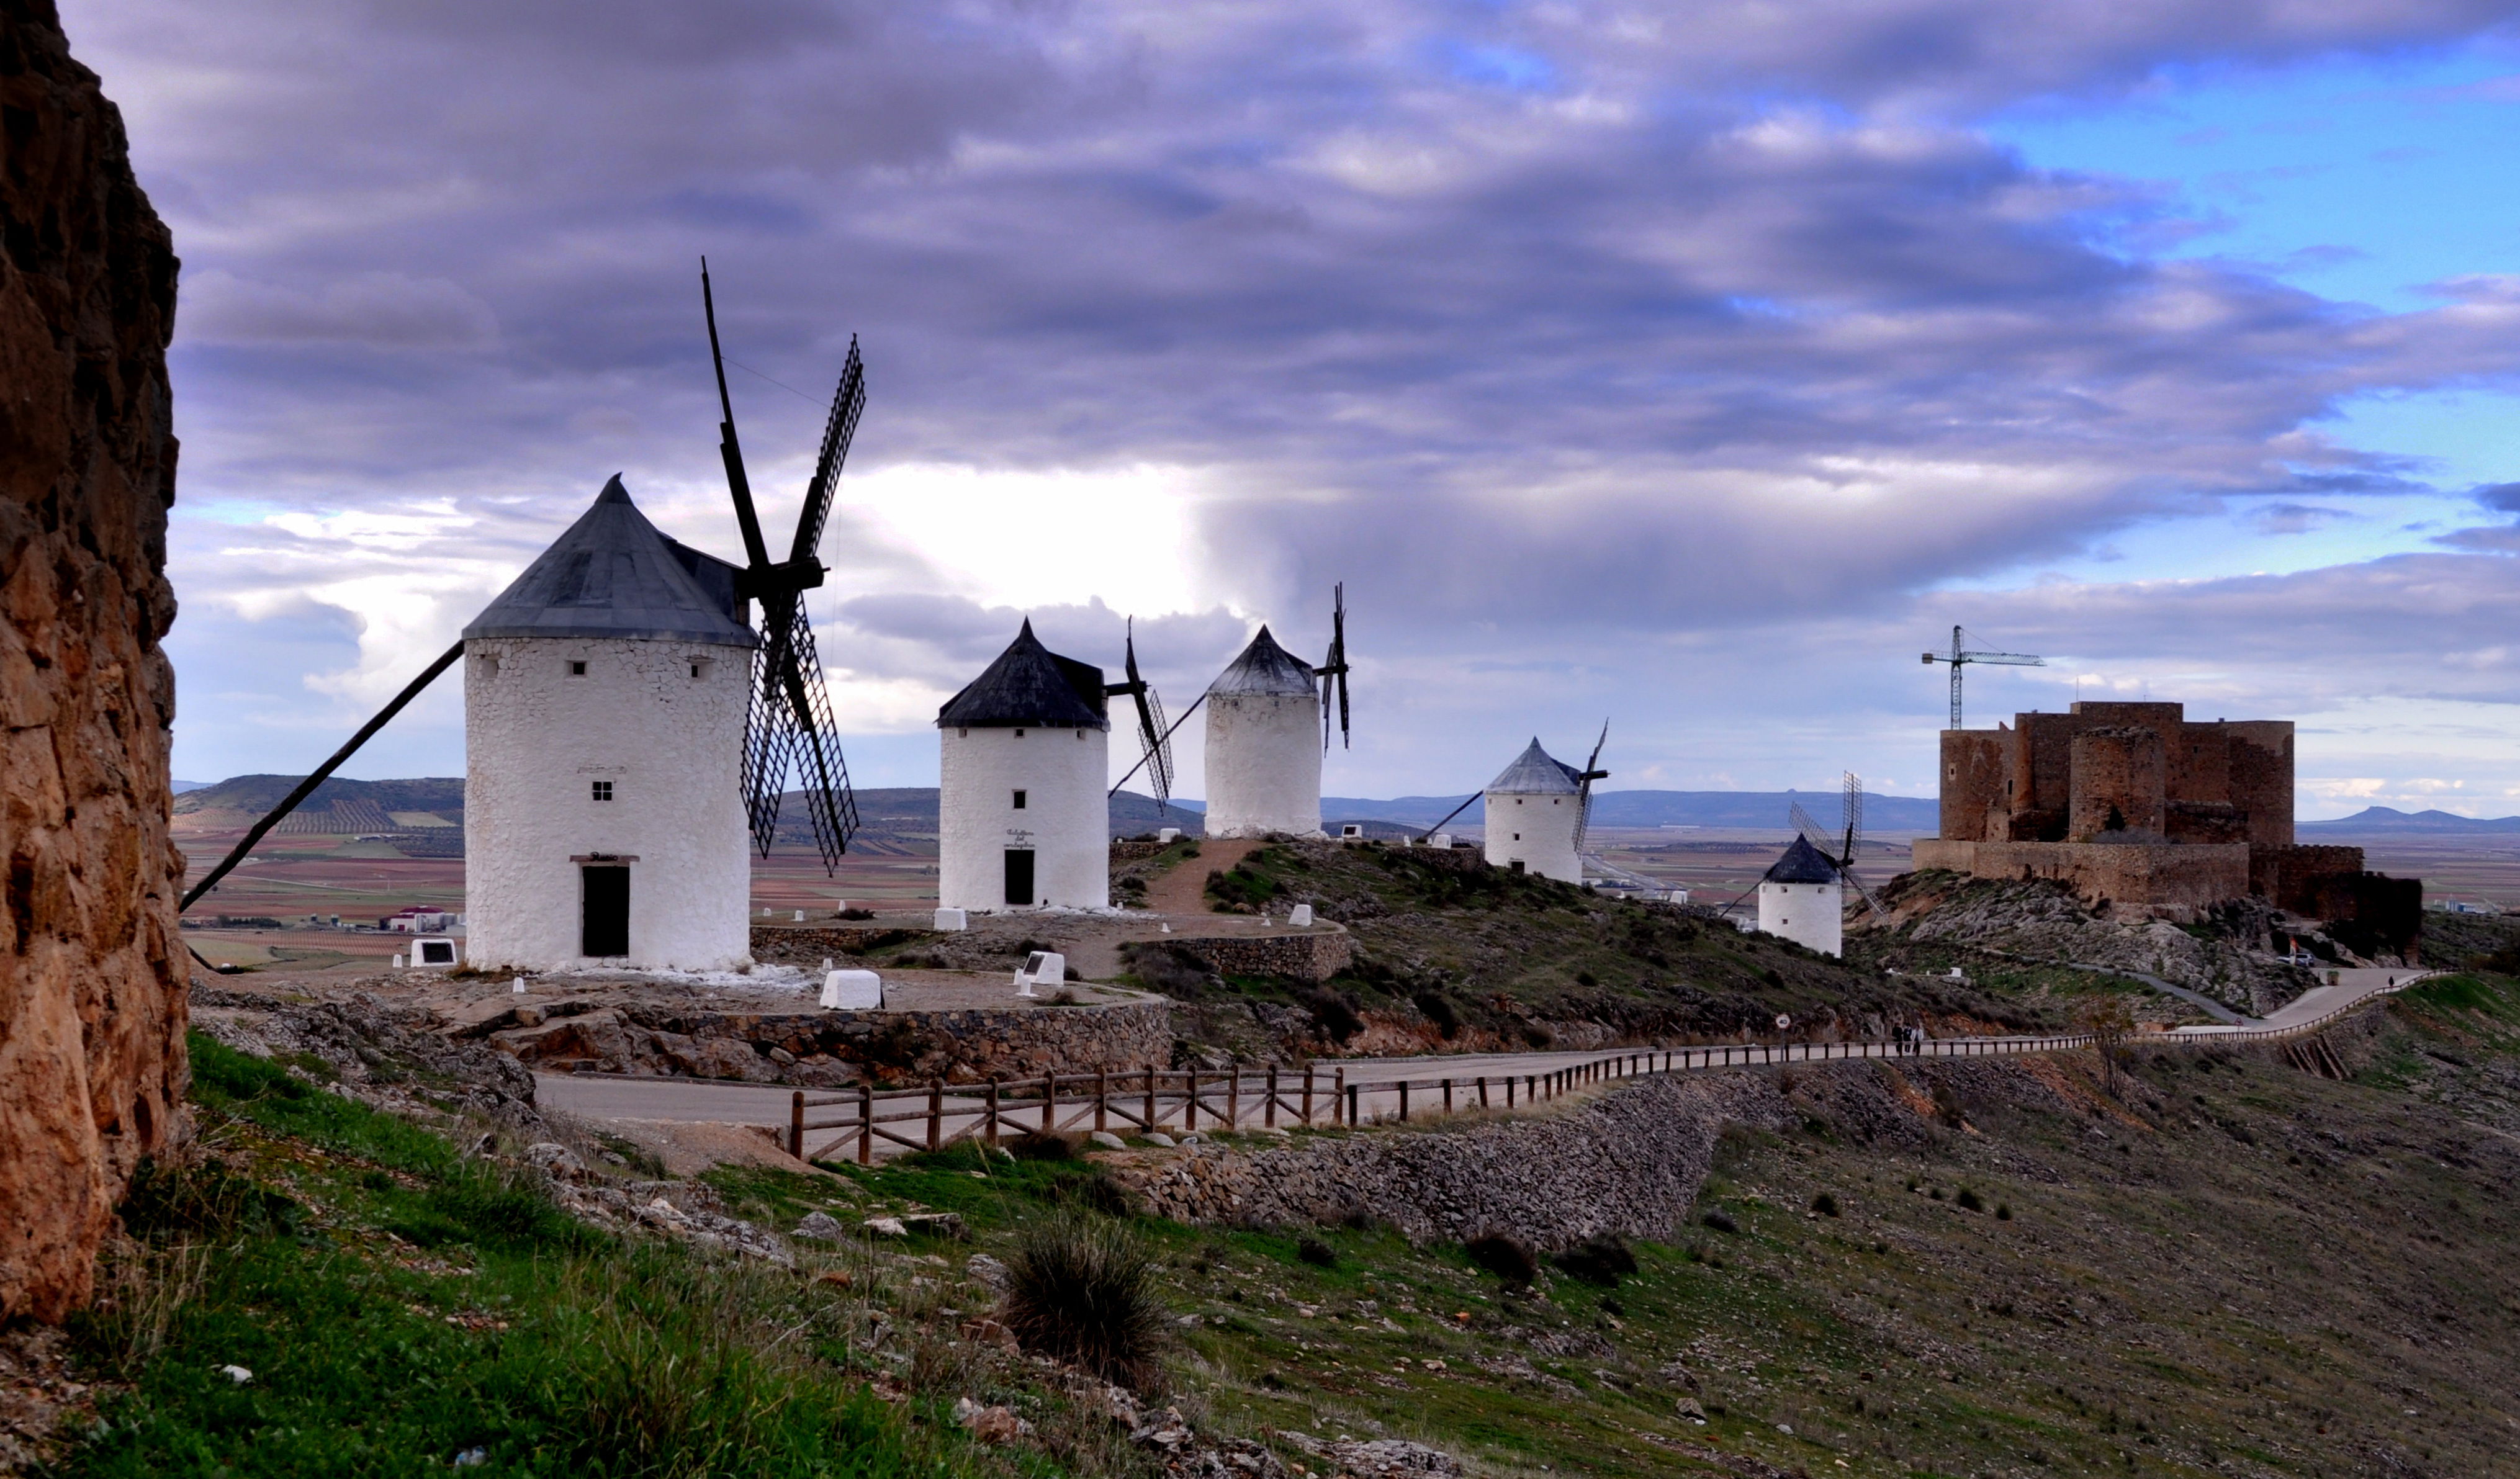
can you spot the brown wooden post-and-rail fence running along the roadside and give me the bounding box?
[786,975,2422,1167]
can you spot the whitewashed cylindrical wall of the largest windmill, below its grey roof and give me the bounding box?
[464,637,754,970]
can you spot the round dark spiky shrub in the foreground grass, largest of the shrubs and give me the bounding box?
[1003,1217,1164,1386]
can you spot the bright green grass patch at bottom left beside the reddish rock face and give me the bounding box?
[63,1036,1008,1479]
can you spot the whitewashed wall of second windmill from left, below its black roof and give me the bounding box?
[937,728,1111,910]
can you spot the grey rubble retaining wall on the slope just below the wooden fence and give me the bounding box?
[1117,1073,1789,1252]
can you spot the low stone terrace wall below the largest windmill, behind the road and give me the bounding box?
[474,1000,1172,1089]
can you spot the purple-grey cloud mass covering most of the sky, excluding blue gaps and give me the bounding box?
[68,0,2520,786]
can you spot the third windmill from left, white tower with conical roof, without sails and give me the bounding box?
[1207,627,1320,837]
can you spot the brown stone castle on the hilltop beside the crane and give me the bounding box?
[1915,703,2422,937]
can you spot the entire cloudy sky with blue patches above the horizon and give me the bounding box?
[63,0,2520,816]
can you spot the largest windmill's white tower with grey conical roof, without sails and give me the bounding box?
[464,476,758,970]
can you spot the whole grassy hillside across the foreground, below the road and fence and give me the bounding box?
[60,973,2520,1477]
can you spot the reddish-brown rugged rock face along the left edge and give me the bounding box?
[0,0,189,1320]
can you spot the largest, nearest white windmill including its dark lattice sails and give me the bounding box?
[466,262,867,970]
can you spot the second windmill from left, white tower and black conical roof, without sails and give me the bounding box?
[937,623,1111,912]
